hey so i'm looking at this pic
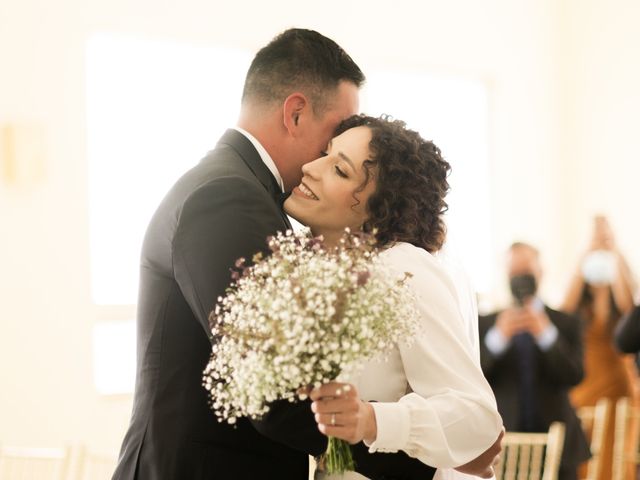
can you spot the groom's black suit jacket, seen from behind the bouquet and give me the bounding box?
[113,130,433,480]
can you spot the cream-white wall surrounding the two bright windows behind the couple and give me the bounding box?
[0,0,640,453]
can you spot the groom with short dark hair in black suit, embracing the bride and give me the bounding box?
[113,29,500,480]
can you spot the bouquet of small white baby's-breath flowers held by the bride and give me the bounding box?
[203,230,418,473]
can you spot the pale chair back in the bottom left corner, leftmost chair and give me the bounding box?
[0,447,71,480]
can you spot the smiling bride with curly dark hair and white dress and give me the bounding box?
[284,115,502,479]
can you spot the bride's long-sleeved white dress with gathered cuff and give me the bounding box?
[315,243,502,480]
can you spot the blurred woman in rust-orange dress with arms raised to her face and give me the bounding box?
[562,216,637,480]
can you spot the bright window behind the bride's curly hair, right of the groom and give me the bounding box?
[361,71,493,292]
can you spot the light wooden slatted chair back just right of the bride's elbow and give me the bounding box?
[495,422,565,480]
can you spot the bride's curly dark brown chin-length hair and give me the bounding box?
[335,115,451,253]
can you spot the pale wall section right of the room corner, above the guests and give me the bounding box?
[561,0,640,284]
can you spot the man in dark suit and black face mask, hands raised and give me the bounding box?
[479,242,590,480]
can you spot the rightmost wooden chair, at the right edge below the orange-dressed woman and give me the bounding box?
[612,397,640,480]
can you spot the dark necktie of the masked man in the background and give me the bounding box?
[512,332,538,432]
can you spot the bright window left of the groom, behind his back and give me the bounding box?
[87,34,251,305]
